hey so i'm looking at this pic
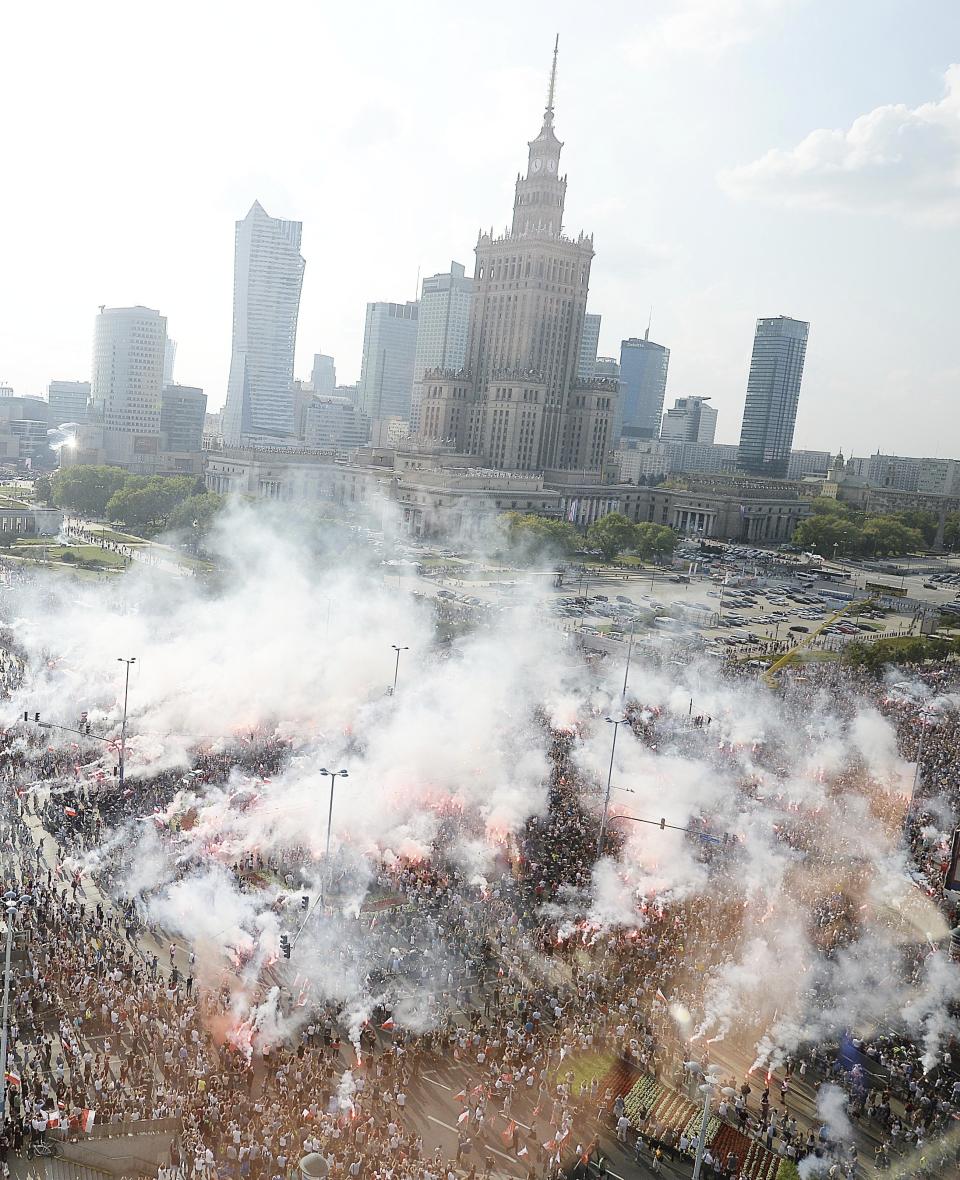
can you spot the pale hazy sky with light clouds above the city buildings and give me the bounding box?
[0,0,960,458]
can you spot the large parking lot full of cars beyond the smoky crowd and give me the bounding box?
[392,542,960,657]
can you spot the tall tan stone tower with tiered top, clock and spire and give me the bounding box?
[421,46,617,473]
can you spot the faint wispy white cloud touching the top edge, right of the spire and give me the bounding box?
[626,0,798,64]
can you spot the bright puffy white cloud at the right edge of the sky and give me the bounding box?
[719,65,960,222]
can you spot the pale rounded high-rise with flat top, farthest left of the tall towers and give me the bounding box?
[88,307,166,472]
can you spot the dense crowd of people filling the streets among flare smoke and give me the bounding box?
[0,654,960,1180]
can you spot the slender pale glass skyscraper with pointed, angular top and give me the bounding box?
[223,201,304,446]
